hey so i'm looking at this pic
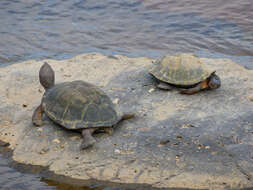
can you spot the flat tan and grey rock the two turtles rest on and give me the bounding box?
[0,54,253,189]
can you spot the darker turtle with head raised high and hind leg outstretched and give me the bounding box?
[32,63,134,149]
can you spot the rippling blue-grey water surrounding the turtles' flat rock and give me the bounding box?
[0,0,253,189]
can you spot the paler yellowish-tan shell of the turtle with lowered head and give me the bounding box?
[149,54,215,86]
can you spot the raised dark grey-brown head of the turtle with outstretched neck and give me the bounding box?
[39,62,54,90]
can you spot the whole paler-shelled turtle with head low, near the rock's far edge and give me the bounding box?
[149,54,221,94]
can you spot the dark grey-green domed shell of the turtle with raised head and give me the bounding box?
[42,81,118,129]
